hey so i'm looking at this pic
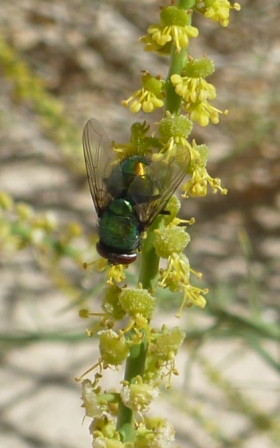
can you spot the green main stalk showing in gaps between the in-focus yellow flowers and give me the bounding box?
[117,0,193,442]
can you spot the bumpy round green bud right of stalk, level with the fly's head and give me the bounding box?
[154,226,190,258]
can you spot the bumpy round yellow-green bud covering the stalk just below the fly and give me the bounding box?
[120,288,156,319]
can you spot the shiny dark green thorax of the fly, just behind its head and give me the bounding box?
[99,199,141,254]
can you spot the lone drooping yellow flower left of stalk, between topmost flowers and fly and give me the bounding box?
[122,72,164,113]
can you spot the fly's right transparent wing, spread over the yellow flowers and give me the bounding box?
[134,146,191,230]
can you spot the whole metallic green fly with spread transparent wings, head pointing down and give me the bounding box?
[83,118,190,265]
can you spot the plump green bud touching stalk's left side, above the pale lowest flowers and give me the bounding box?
[99,330,130,366]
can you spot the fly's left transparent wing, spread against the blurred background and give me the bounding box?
[83,118,120,216]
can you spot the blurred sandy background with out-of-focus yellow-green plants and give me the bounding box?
[0,0,280,448]
